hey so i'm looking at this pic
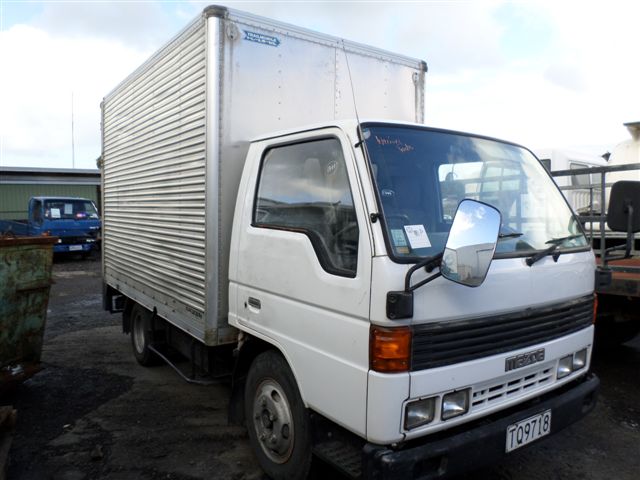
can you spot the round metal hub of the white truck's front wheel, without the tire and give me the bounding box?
[253,379,294,463]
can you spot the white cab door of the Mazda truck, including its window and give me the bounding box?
[230,128,372,434]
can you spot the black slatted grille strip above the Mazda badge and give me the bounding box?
[411,295,593,371]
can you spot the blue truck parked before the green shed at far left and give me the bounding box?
[0,197,102,255]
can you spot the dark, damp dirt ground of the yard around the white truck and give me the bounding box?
[0,258,640,480]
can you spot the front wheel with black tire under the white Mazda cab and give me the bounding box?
[244,350,312,480]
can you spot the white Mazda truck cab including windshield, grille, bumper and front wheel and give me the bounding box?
[229,121,598,478]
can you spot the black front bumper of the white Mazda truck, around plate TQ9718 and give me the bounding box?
[363,374,600,480]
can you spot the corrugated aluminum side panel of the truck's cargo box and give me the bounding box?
[103,20,206,339]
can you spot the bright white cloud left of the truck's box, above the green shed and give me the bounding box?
[0,25,149,168]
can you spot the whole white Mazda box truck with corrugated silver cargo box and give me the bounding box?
[102,7,598,479]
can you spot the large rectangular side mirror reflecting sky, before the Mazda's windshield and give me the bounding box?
[440,199,502,287]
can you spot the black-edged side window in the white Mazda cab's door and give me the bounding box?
[253,138,359,277]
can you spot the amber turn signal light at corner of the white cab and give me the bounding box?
[369,325,411,373]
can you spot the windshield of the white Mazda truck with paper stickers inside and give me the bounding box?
[363,124,588,261]
